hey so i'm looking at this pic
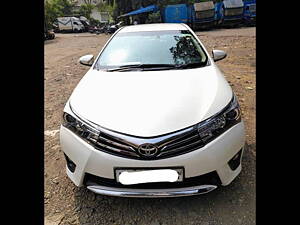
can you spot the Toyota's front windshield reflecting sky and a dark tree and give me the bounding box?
[95,30,208,69]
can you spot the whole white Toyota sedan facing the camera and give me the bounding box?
[60,24,245,197]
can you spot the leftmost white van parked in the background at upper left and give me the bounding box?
[57,16,85,33]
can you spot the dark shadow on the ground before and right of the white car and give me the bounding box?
[74,145,256,225]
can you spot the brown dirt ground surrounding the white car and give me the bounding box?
[44,27,256,225]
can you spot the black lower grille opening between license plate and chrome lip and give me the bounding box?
[83,171,221,189]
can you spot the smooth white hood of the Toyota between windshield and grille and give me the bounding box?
[69,65,232,137]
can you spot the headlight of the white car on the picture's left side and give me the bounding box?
[63,112,100,144]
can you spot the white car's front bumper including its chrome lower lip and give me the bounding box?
[60,122,245,197]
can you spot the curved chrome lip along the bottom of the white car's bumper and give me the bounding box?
[87,184,217,198]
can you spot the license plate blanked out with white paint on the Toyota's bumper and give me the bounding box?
[116,168,183,185]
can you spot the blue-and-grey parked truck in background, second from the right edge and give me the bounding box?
[214,0,244,25]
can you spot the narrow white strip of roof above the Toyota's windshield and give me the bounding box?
[119,23,188,33]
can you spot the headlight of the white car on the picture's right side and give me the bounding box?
[198,95,241,143]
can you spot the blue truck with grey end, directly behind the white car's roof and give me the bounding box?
[161,1,215,29]
